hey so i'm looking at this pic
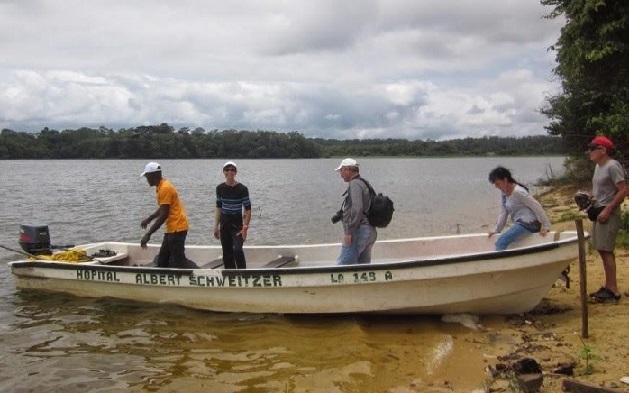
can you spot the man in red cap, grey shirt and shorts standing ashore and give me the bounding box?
[588,136,627,302]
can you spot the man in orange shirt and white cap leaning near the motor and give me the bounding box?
[140,162,198,269]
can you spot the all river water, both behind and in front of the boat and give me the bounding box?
[0,157,563,392]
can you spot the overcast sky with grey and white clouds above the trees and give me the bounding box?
[0,0,563,140]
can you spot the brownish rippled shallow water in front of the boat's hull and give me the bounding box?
[3,292,490,392]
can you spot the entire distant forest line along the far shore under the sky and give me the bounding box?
[0,123,565,159]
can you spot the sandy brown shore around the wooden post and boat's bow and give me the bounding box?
[472,188,629,392]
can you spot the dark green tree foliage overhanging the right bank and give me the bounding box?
[541,0,629,167]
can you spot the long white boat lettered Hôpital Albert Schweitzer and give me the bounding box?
[9,232,579,315]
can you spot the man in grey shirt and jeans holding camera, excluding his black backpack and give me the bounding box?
[336,158,378,265]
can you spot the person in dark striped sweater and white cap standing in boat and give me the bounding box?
[214,161,251,269]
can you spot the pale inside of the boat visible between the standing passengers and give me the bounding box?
[35,231,587,269]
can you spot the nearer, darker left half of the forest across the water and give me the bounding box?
[0,127,322,159]
